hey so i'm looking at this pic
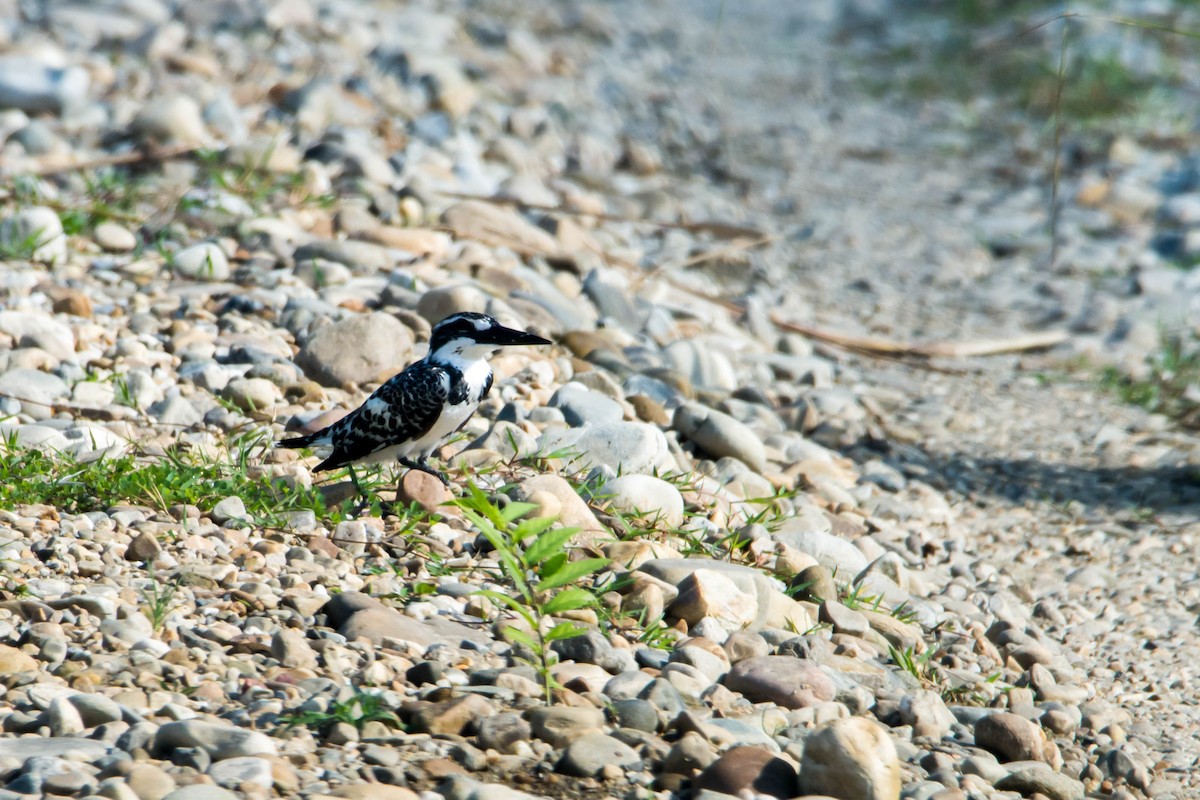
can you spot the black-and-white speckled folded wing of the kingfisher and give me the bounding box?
[307,361,450,470]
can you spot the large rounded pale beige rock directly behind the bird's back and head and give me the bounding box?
[295,312,413,386]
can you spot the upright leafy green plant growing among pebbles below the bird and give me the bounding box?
[455,485,608,704]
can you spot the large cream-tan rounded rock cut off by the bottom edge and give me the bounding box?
[797,717,900,800]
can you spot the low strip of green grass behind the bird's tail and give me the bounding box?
[0,441,341,527]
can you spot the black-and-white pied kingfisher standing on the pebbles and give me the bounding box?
[278,312,551,483]
